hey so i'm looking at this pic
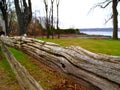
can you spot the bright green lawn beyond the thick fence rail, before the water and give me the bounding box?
[38,38,120,56]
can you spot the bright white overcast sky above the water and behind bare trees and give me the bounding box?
[32,0,119,28]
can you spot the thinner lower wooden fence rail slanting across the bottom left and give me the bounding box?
[1,44,43,90]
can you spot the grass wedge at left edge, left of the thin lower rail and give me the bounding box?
[0,48,21,90]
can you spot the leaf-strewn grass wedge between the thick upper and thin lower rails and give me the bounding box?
[9,48,87,90]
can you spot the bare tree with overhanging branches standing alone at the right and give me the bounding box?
[94,0,120,39]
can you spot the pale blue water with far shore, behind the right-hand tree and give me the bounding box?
[80,28,120,38]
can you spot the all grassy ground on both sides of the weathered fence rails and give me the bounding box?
[0,38,120,90]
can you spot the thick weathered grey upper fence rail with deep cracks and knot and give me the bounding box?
[0,37,120,90]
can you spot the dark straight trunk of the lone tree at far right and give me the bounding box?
[112,0,118,39]
